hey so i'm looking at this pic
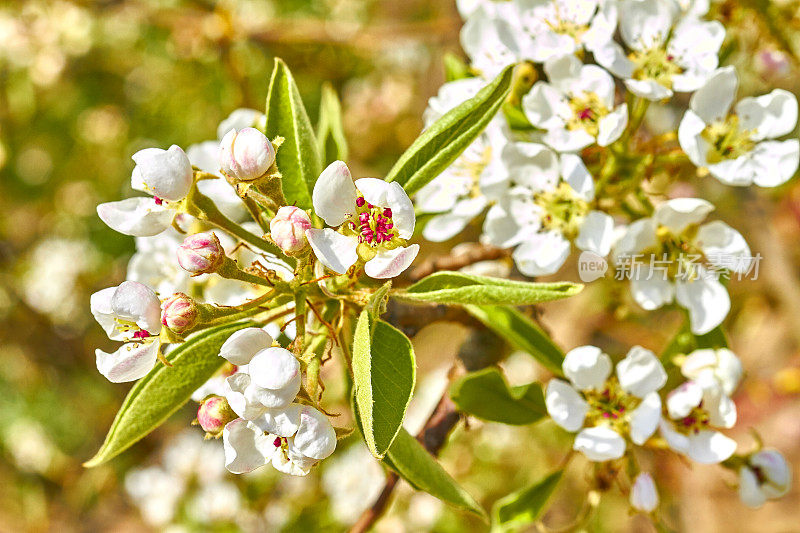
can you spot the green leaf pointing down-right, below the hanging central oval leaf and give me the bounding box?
[383,429,487,520]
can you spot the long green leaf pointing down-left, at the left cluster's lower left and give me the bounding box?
[84,322,255,467]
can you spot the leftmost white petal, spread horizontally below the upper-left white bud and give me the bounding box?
[97,196,174,237]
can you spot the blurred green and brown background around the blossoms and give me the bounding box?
[0,0,800,531]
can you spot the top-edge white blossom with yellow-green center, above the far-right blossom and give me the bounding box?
[593,0,725,100]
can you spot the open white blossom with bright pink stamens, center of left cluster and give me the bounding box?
[306,161,419,279]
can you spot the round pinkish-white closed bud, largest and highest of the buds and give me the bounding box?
[219,128,275,181]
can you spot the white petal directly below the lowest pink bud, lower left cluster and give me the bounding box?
[222,418,275,474]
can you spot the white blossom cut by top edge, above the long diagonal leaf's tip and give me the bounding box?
[516,0,617,63]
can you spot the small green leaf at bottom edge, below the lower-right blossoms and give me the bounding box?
[492,470,564,531]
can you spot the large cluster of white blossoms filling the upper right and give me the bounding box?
[422,0,800,334]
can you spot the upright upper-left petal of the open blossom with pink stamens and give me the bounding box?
[312,161,358,227]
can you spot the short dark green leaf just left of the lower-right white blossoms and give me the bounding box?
[450,367,547,426]
